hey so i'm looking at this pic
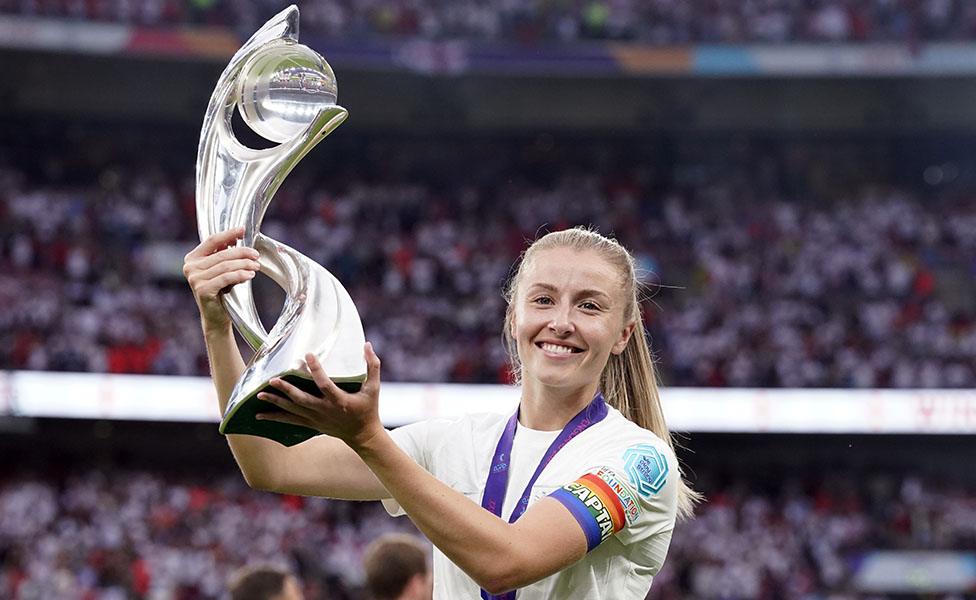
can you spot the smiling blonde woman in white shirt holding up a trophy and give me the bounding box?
[184,228,698,599]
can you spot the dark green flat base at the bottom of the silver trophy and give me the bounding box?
[220,374,363,446]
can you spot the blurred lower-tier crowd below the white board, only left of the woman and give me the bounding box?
[0,470,416,600]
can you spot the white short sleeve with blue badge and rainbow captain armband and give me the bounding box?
[550,440,680,551]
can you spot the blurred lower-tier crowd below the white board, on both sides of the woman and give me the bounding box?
[0,470,976,600]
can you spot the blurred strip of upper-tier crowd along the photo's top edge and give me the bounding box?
[0,0,976,45]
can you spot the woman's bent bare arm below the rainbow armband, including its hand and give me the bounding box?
[259,344,587,594]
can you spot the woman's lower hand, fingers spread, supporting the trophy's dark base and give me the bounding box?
[257,342,383,450]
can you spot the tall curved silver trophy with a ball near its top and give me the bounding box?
[196,5,366,446]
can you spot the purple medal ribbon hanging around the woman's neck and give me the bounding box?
[481,392,608,600]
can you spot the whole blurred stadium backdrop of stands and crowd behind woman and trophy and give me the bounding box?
[0,0,976,600]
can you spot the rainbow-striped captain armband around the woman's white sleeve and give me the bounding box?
[550,467,642,552]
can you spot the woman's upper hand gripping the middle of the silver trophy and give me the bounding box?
[183,227,261,329]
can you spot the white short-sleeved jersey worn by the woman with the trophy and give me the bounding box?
[383,407,680,600]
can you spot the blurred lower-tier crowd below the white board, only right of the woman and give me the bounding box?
[648,474,976,600]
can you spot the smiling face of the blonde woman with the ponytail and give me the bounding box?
[511,247,635,389]
